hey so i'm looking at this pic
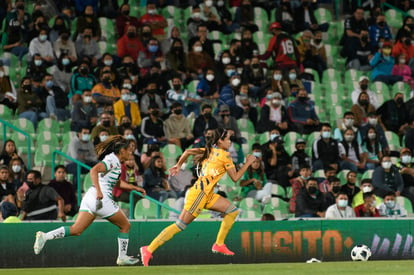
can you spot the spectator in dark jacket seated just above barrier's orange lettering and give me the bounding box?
[295,178,327,218]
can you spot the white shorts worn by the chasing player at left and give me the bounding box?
[79,186,119,219]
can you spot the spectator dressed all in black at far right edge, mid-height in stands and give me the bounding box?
[377,92,408,135]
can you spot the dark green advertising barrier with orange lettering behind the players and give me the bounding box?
[0,219,414,267]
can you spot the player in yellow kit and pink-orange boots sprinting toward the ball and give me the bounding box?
[140,128,256,266]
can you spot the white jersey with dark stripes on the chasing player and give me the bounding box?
[98,153,121,198]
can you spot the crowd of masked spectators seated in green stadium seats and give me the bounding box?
[0,0,414,220]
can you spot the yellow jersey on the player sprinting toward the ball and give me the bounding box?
[194,148,234,194]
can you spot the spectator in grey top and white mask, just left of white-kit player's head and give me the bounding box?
[66,125,98,190]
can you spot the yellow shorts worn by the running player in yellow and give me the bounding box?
[184,186,221,217]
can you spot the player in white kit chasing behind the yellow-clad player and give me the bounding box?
[33,135,145,265]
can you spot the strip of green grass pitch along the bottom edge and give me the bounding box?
[4,261,414,275]
